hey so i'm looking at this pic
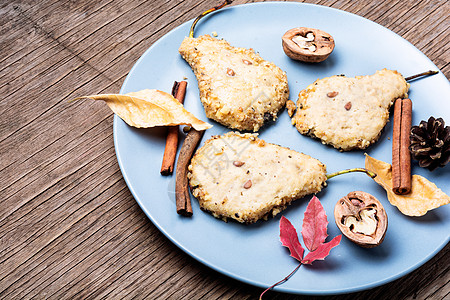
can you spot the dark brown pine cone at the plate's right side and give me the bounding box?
[409,117,450,171]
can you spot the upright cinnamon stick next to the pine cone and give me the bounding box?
[392,99,412,195]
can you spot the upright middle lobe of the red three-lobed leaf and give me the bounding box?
[302,196,328,251]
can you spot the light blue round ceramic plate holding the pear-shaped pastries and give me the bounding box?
[114,3,450,295]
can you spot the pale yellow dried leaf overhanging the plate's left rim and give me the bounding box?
[75,89,212,130]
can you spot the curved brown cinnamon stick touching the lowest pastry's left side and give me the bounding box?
[175,128,205,217]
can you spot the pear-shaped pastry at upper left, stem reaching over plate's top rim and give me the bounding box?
[179,35,289,132]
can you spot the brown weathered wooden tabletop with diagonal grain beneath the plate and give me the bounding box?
[0,0,450,299]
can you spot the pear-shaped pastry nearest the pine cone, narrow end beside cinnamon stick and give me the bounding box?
[292,69,409,151]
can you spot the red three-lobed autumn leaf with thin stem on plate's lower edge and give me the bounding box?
[259,196,342,299]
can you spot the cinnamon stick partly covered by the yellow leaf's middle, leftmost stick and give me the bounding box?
[161,81,187,175]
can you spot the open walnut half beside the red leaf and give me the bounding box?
[334,191,388,248]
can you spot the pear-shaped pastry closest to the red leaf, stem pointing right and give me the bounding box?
[188,132,327,223]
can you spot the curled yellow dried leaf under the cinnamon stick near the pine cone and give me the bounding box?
[365,154,450,217]
